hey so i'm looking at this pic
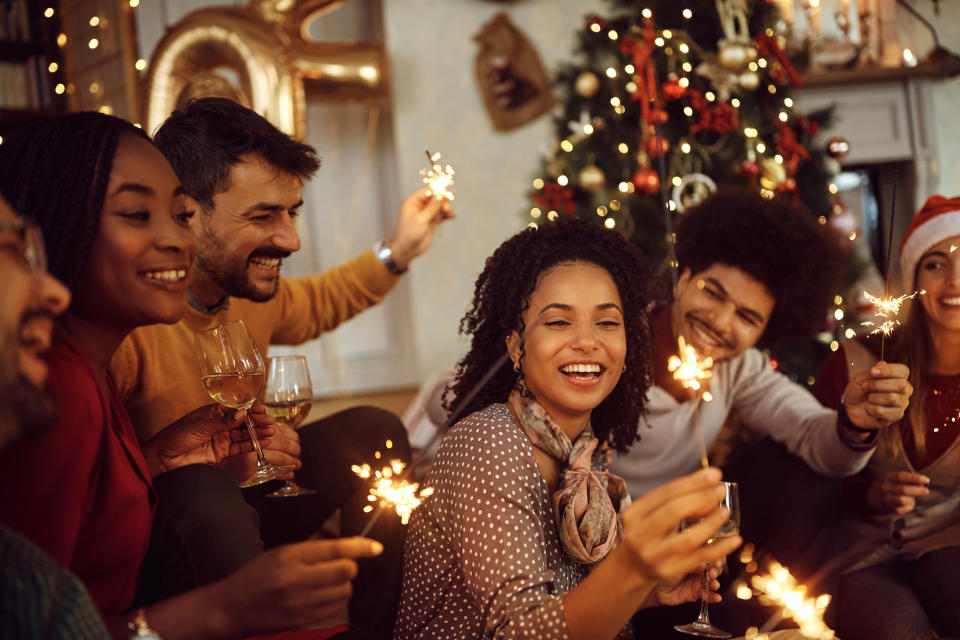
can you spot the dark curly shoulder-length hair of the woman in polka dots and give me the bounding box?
[445,219,652,452]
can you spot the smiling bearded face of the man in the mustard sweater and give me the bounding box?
[192,156,303,305]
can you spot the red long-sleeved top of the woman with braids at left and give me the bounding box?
[0,328,155,622]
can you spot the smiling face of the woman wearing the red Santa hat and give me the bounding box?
[915,235,960,331]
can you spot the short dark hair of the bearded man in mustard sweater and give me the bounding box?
[153,98,320,211]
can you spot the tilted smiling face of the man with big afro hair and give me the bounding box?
[671,263,775,360]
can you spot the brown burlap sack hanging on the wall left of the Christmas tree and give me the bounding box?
[473,12,554,131]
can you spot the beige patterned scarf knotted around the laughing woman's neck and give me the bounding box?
[507,391,630,564]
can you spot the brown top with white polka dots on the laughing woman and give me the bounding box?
[395,404,630,640]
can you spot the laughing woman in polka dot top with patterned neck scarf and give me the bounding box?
[396,220,740,640]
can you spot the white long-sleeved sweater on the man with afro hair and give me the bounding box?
[610,349,873,497]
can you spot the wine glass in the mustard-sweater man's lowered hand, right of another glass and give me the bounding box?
[262,356,316,498]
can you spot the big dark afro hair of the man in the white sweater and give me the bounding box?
[677,188,844,344]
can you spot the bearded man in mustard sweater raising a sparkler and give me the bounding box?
[111,98,453,634]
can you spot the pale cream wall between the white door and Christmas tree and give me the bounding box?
[384,0,608,376]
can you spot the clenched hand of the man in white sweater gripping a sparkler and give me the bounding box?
[843,360,913,429]
